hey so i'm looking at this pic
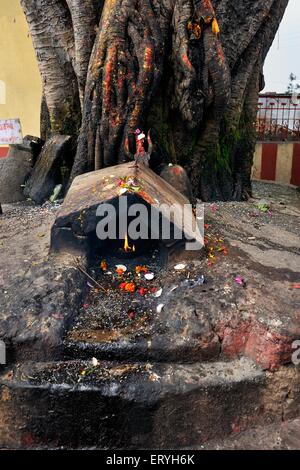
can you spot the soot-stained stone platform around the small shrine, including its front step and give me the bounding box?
[0,184,300,448]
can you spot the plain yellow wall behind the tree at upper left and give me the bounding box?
[0,0,42,136]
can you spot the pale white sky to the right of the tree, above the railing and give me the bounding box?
[264,0,300,92]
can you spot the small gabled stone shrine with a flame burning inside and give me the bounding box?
[51,164,199,257]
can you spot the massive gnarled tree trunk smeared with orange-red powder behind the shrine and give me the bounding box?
[21,0,288,200]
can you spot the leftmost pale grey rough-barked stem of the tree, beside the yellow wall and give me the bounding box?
[21,0,81,134]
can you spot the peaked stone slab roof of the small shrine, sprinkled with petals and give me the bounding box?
[51,162,202,253]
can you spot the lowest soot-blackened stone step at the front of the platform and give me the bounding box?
[0,358,266,449]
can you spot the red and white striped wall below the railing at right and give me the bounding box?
[252,142,300,186]
